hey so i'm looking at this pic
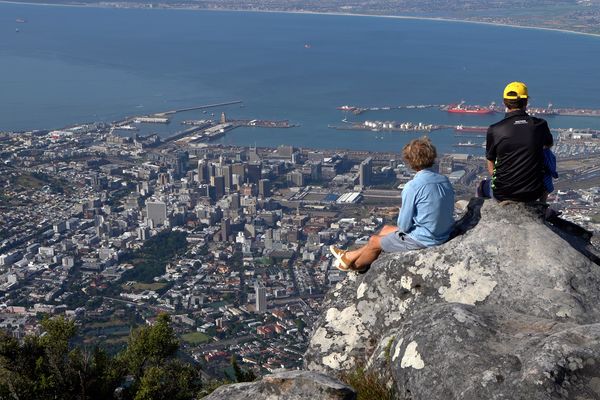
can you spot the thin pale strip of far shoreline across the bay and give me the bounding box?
[0,0,600,37]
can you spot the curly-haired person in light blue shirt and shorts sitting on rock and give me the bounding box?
[330,137,454,271]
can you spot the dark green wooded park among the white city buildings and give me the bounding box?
[122,231,187,283]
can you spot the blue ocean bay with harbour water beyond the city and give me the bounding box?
[0,4,600,152]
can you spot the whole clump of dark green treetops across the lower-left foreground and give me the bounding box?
[0,314,201,400]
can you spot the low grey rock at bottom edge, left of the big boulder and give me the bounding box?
[204,371,356,400]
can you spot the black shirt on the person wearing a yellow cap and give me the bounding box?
[486,110,553,202]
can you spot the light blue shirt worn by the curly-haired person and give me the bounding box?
[398,169,454,247]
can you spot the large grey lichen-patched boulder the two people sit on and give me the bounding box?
[305,201,600,400]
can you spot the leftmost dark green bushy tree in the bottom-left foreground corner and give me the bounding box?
[0,317,124,400]
